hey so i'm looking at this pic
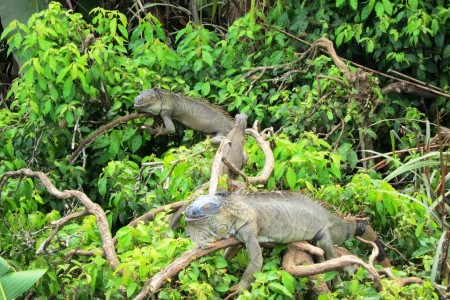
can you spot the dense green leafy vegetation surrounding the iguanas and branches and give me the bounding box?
[0,0,450,299]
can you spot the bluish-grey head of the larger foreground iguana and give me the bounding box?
[184,195,234,248]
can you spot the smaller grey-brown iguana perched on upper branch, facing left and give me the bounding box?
[134,88,233,144]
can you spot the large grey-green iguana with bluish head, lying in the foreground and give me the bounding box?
[185,192,390,291]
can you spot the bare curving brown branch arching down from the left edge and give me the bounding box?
[0,169,120,270]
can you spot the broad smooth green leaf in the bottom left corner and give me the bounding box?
[0,269,47,299]
